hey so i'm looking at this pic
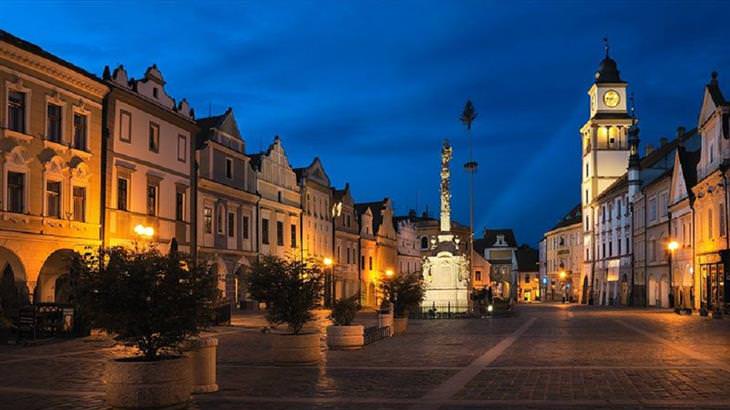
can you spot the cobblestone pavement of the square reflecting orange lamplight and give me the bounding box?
[0,305,730,410]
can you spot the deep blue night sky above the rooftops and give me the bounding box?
[0,1,730,245]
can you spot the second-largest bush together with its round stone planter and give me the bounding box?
[248,256,322,365]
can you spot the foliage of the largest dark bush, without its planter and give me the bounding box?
[70,247,219,361]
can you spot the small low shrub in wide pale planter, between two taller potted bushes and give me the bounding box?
[327,296,365,350]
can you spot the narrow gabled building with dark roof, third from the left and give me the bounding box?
[195,108,259,305]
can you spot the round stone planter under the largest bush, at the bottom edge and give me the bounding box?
[104,356,192,408]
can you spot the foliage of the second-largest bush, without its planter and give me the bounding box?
[248,256,322,334]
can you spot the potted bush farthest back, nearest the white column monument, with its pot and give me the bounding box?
[381,273,425,335]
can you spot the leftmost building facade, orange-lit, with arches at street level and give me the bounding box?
[0,31,108,303]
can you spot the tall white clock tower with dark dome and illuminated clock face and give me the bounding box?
[580,44,633,271]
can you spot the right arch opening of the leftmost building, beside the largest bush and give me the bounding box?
[33,249,74,303]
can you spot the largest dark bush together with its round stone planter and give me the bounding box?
[70,247,218,407]
